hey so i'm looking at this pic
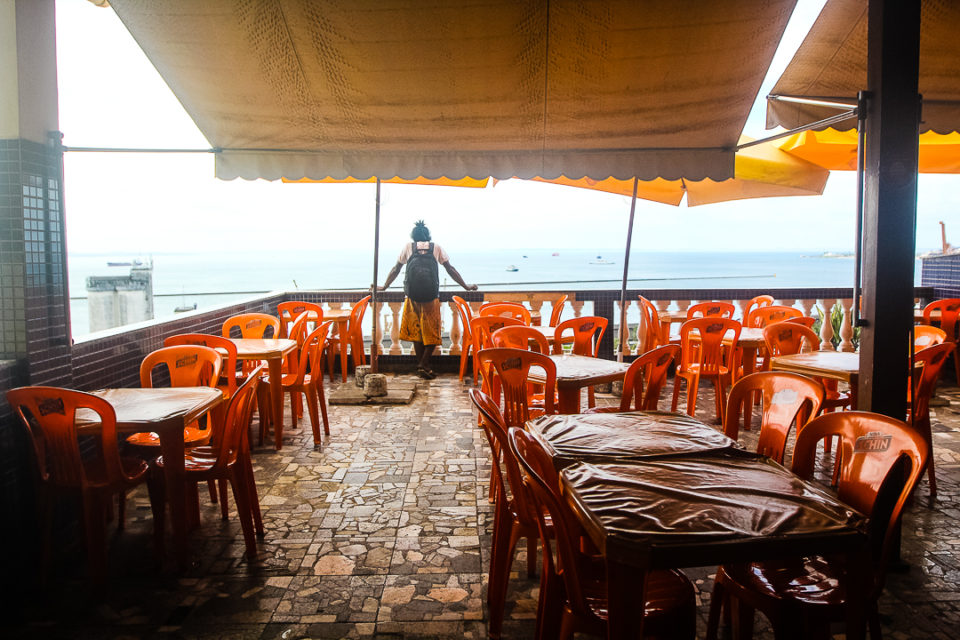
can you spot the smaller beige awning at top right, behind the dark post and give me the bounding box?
[767,0,960,133]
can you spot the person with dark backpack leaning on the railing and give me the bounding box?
[379,220,477,380]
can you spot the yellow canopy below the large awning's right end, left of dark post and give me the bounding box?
[520,136,830,207]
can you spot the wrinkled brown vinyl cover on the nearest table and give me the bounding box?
[561,451,866,548]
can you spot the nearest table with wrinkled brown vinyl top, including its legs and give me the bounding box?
[560,451,870,638]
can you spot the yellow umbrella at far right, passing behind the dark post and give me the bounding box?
[780,129,960,173]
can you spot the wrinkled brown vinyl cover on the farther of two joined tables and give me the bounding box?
[526,411,739,468]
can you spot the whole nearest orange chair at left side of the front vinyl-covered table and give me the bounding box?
[508,428,696,640]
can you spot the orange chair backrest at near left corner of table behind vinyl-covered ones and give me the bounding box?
[477,347,557,427]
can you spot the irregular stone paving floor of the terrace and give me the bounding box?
[0,375,960,640]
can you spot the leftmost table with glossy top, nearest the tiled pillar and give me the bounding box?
[77,387,223,569]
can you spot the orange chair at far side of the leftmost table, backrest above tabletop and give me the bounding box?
[127,344,223,447]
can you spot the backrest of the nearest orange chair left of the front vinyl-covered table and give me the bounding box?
[507,427,591,616]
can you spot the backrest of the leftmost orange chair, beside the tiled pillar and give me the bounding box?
[7,387,125,489]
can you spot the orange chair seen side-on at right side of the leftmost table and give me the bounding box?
[156,375,263,560]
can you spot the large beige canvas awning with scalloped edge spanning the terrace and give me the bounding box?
[103,0,794,180]
